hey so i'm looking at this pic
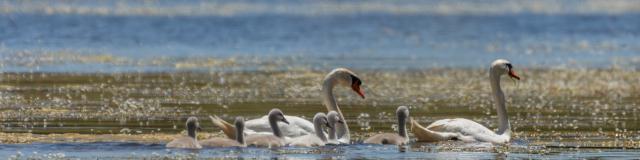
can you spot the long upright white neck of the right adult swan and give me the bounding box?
[489,68,511,134]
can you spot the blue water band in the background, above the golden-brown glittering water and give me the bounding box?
[0,1,640,72]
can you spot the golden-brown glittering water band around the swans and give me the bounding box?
[0,68,640,158]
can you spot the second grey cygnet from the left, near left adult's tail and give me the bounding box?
[200,117,245,147]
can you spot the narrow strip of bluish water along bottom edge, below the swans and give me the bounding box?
[0,142,640,159]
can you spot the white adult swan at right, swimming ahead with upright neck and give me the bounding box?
[411,59,520,143]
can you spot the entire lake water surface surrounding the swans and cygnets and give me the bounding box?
[0,0,640,159]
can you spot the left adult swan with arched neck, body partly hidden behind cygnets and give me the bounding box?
[210,68,364,143]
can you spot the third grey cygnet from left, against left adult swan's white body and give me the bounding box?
[245,109,289,148]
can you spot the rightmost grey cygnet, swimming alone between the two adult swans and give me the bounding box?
[363,106,409,145]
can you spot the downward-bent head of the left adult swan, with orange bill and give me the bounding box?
[325,68,364,99]
